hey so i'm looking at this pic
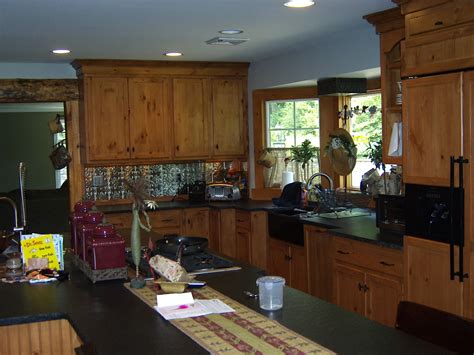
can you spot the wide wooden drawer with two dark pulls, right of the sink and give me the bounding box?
[334,238,403,277]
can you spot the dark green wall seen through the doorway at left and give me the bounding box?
[0,112,62,192]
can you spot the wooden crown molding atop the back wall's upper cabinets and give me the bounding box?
[71,59,249,77]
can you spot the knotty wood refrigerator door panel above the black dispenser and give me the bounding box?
[402,73,462,186]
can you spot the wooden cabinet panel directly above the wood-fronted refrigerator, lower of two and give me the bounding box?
[402,24,474,77]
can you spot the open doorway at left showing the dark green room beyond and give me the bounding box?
[0,102,69,233]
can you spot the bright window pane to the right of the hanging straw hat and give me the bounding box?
[350,93,382,189]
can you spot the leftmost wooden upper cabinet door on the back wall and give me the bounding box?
[82,77,130,162]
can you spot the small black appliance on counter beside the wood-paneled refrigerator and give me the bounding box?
[375,194,405,234]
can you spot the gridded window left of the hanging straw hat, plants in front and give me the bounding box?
[264,99,320,187]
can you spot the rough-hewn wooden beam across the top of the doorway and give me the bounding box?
[0,79,79,103]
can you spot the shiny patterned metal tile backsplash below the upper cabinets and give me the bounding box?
[84,161,247,200]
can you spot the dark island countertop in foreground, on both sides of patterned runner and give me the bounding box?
[0,263,449,354]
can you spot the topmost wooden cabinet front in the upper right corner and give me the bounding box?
[405,1,474,39]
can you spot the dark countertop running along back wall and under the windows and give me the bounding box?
[99,200,403,249]
